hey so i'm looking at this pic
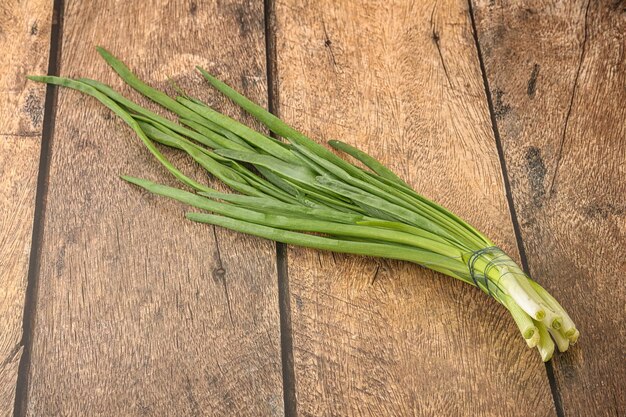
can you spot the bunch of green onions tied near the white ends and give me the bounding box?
[29,48,579,361]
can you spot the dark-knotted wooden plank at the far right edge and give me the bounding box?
[475,1,626,416]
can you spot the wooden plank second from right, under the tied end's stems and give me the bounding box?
[276,0,554,416]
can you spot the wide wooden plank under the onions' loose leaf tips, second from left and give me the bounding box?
[27,0,283,416]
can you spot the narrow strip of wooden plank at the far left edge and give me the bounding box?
[0,0,52,416]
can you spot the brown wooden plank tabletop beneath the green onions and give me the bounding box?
[0,0,626,416]
